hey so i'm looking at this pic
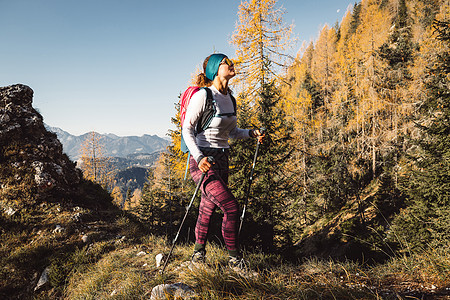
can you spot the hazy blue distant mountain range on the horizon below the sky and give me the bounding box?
[46,125,170,161]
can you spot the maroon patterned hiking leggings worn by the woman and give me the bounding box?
[189,148,239,251]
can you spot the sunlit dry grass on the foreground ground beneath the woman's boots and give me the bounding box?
[59,236,450,299]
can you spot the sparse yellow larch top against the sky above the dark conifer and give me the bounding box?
[231,0,293,103]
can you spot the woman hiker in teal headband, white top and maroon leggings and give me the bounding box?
[182,53,264,267]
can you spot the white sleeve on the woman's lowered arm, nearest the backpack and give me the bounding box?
[181,89,206,162]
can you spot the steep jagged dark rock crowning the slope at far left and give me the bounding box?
[0,84,82,198]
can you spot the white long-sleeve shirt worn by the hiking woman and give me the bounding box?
[182,86,250,162]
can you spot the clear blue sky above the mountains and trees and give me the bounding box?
[0,0,355,137]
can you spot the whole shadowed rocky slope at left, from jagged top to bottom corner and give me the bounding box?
[0,84,125,299]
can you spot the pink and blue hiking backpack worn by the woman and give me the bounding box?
[180,86,236,157]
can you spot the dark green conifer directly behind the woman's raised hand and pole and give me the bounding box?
[230,83,295,251]
